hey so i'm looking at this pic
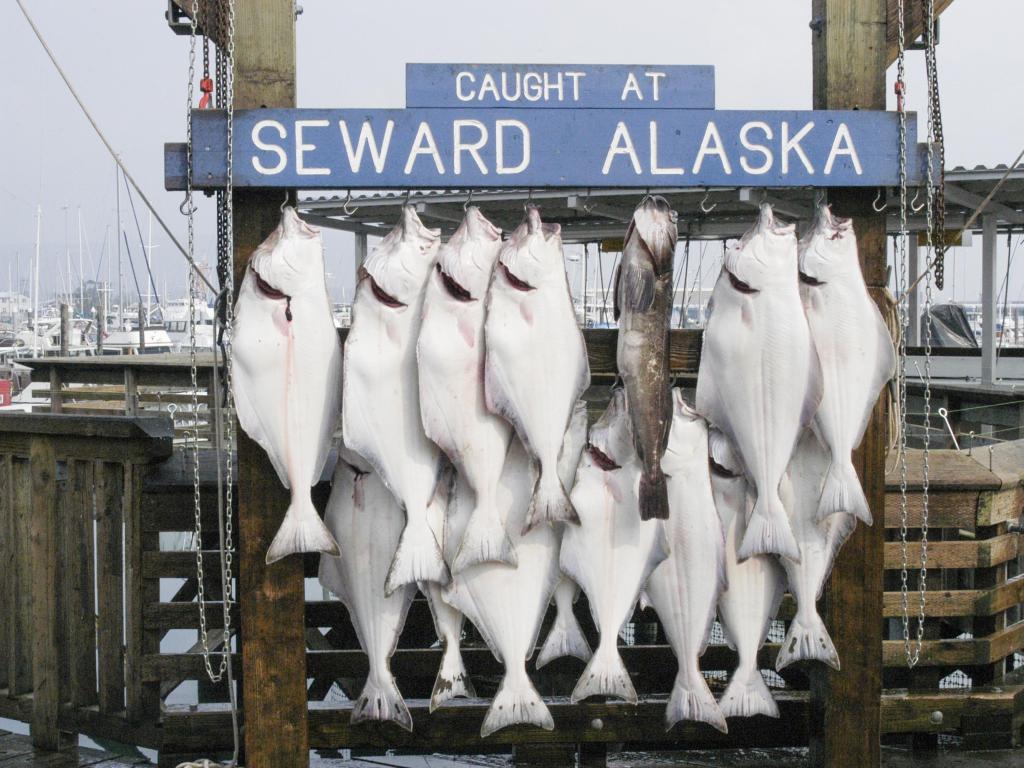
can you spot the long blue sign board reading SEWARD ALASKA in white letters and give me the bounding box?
[165,106,924,189]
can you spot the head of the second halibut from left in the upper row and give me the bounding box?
[359,206,440,310]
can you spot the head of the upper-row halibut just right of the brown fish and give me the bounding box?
[723,203,797,295]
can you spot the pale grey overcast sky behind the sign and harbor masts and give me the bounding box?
[0,0,1024,309]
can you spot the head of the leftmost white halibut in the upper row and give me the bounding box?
[249,206,325,298]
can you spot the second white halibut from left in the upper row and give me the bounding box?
[341,206,449,592]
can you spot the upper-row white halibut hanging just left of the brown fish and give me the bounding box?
[483,206,590,530]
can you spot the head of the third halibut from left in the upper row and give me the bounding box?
[435,206,502,301]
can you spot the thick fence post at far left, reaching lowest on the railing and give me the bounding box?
[30,437,61,750]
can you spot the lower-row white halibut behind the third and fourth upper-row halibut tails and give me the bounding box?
[444,403,587,736]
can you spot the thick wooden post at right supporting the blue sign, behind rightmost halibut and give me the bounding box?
[810,0,887,768]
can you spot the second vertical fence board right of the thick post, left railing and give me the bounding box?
[93,462,125,714]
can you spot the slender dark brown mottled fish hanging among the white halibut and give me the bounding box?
[614,195,678,520]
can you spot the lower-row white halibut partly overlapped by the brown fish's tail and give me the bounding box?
[559,389,666,703]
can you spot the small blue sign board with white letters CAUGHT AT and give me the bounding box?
[406,63,715,110]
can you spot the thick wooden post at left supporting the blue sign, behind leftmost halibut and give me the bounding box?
[233,0,309,768]
